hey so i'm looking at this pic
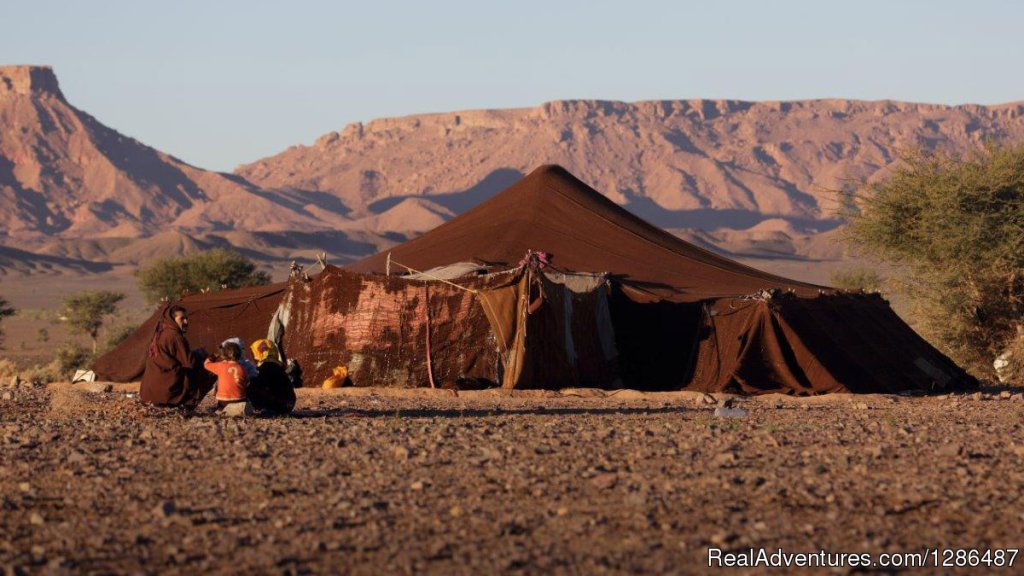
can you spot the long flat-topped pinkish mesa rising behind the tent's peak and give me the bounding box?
[237,99,1024,255]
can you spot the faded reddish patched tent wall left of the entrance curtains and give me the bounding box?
[280,268,500,387]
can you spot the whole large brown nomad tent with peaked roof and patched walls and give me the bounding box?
[95,166,975,395]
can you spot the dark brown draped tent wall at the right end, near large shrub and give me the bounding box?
[687,294,975,396]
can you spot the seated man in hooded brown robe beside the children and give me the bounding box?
[139,305,213,408]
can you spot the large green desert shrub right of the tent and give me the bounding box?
[845,146,1024,376]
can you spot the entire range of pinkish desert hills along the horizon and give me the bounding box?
[6,67,1024,272]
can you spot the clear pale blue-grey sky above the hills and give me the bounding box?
[0,0,1024,170]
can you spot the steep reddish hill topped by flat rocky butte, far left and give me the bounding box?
[0,67,383,270]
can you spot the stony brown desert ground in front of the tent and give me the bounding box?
[0,384,1024,574]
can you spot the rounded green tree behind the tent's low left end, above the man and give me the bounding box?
[135,248,270,303]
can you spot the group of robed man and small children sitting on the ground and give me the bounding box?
[139,305,295,415]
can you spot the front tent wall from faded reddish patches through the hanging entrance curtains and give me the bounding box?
[280,268,622,388]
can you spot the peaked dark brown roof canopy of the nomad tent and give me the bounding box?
[347,166,823,301]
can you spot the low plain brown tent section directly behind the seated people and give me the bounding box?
[91,283,288,382]
